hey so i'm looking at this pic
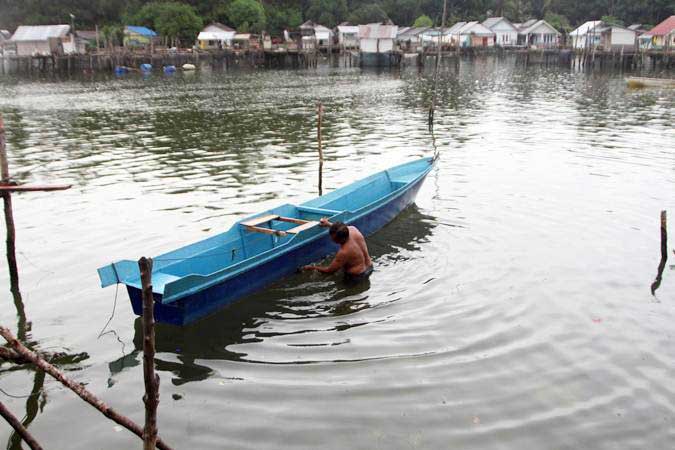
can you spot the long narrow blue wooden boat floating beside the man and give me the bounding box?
[98,158,434,325]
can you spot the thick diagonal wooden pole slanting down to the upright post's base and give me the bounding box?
[0,326,177,450]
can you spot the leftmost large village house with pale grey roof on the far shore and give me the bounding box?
[9,25,86,56]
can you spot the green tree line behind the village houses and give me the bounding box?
[0,0,675,42]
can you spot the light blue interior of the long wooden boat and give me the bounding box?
[99,159,430,293]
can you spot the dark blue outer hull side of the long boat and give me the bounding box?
[127,171,425,325]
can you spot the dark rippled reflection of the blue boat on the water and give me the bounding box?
[118,205,436,385]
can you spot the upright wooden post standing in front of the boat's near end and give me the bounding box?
[138,257,159,450]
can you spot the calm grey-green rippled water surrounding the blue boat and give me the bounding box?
[0,59,675,450]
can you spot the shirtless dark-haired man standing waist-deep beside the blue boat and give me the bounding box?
[302,219,373,281]
